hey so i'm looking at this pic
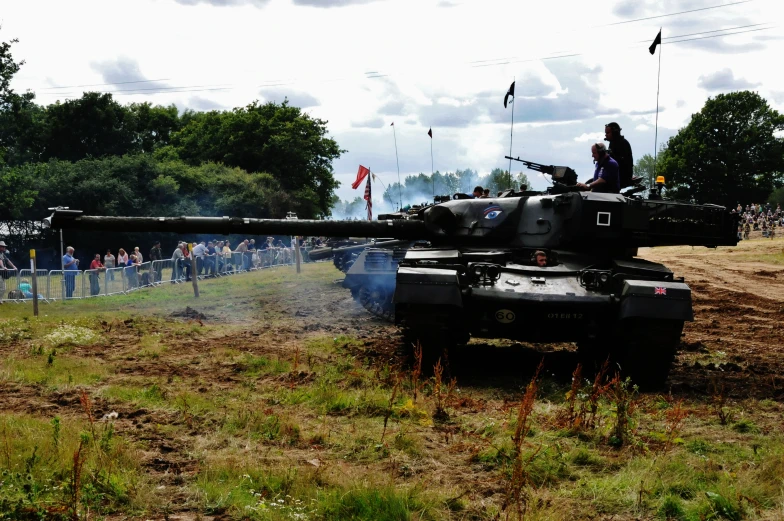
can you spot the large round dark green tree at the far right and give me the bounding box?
[658,91,784,207]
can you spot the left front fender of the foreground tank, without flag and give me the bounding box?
[392,267,463,308]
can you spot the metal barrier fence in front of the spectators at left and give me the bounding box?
[0,248,305,302]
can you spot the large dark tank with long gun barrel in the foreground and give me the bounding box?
[45,163,737,388]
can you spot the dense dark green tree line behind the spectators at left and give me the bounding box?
[0,34,345,262]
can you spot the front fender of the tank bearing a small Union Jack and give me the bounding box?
[618,280,694,321]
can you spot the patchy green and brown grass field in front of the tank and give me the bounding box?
[0,251,784,521]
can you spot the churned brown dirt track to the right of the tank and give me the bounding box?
[640,239,784,399]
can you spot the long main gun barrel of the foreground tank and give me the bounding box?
[44,210,430,239]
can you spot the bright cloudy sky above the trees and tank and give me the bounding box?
[0,0,784,199]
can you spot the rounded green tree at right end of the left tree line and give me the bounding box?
[172,101,345,217]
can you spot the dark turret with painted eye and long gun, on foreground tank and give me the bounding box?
[44,192,737,251]
